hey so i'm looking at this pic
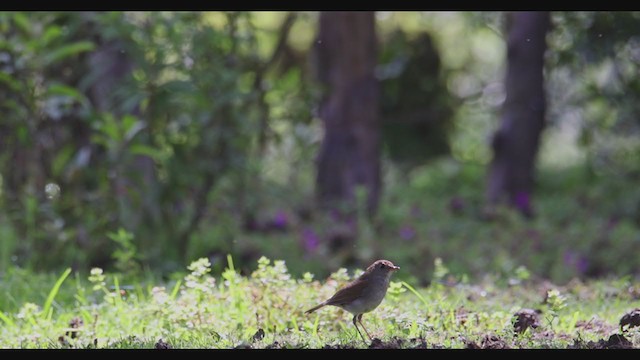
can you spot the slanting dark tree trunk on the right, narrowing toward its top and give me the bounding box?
[487,12,550,216]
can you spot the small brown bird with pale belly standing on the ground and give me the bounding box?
[305,260,400,343]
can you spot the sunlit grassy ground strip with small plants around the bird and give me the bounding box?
[0,258,640,349]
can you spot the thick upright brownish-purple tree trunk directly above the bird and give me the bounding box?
[316,12,380,214]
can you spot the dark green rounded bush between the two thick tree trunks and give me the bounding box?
[377,30,453,167]
